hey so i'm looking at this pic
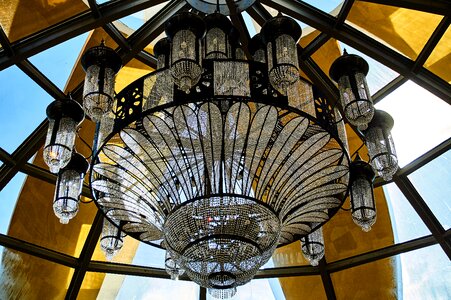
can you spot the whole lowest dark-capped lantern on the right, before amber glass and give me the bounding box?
[350,154,376,232]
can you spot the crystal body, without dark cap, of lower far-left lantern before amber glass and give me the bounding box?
[53,170,83,224]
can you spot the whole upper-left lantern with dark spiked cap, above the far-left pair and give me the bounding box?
[81,41,122,122]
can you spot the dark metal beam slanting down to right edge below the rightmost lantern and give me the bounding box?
[394,176,451,259]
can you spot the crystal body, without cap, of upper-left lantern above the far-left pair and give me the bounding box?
[83,65,115,122]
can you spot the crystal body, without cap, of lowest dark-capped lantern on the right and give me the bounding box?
[351,177,376,232]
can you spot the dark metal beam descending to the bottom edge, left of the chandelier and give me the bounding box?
[65,210,103,300]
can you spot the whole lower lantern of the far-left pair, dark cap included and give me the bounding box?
[53,153,89,224]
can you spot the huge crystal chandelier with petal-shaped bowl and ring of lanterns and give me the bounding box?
[45,1,396,298]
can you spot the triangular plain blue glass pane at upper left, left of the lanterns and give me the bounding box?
[30,33,88,90]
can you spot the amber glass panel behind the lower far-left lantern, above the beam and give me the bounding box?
[8,175,97,257]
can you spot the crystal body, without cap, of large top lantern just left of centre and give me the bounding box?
[171,30,202,93]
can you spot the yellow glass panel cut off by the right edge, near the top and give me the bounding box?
[424,27,451,83]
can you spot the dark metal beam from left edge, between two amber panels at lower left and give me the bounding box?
[0,233,78,268]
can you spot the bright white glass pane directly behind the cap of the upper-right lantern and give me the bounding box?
[338,42,399,95]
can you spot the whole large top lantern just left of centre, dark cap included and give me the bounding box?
[165,12,205,94]
